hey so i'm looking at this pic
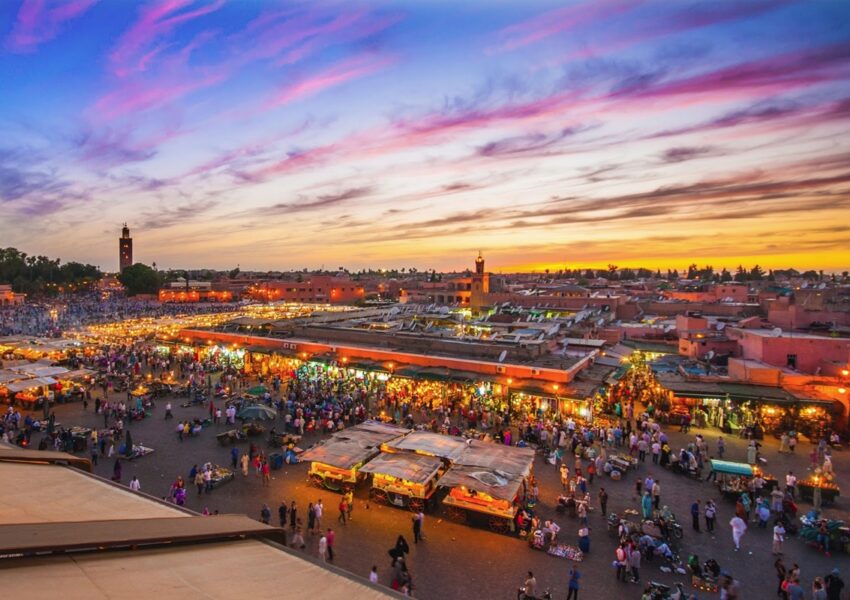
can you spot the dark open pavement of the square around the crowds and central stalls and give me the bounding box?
[34,399,850,599]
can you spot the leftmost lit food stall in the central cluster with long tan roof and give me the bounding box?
[301,421,410,492]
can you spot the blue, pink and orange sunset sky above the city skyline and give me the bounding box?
[0,0,850,271]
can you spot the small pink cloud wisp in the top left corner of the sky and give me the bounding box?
[5,0,98,53]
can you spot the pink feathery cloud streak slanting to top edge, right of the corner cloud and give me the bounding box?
[110,0,224,77]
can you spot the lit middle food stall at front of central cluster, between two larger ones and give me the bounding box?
[360,452,445,512]
